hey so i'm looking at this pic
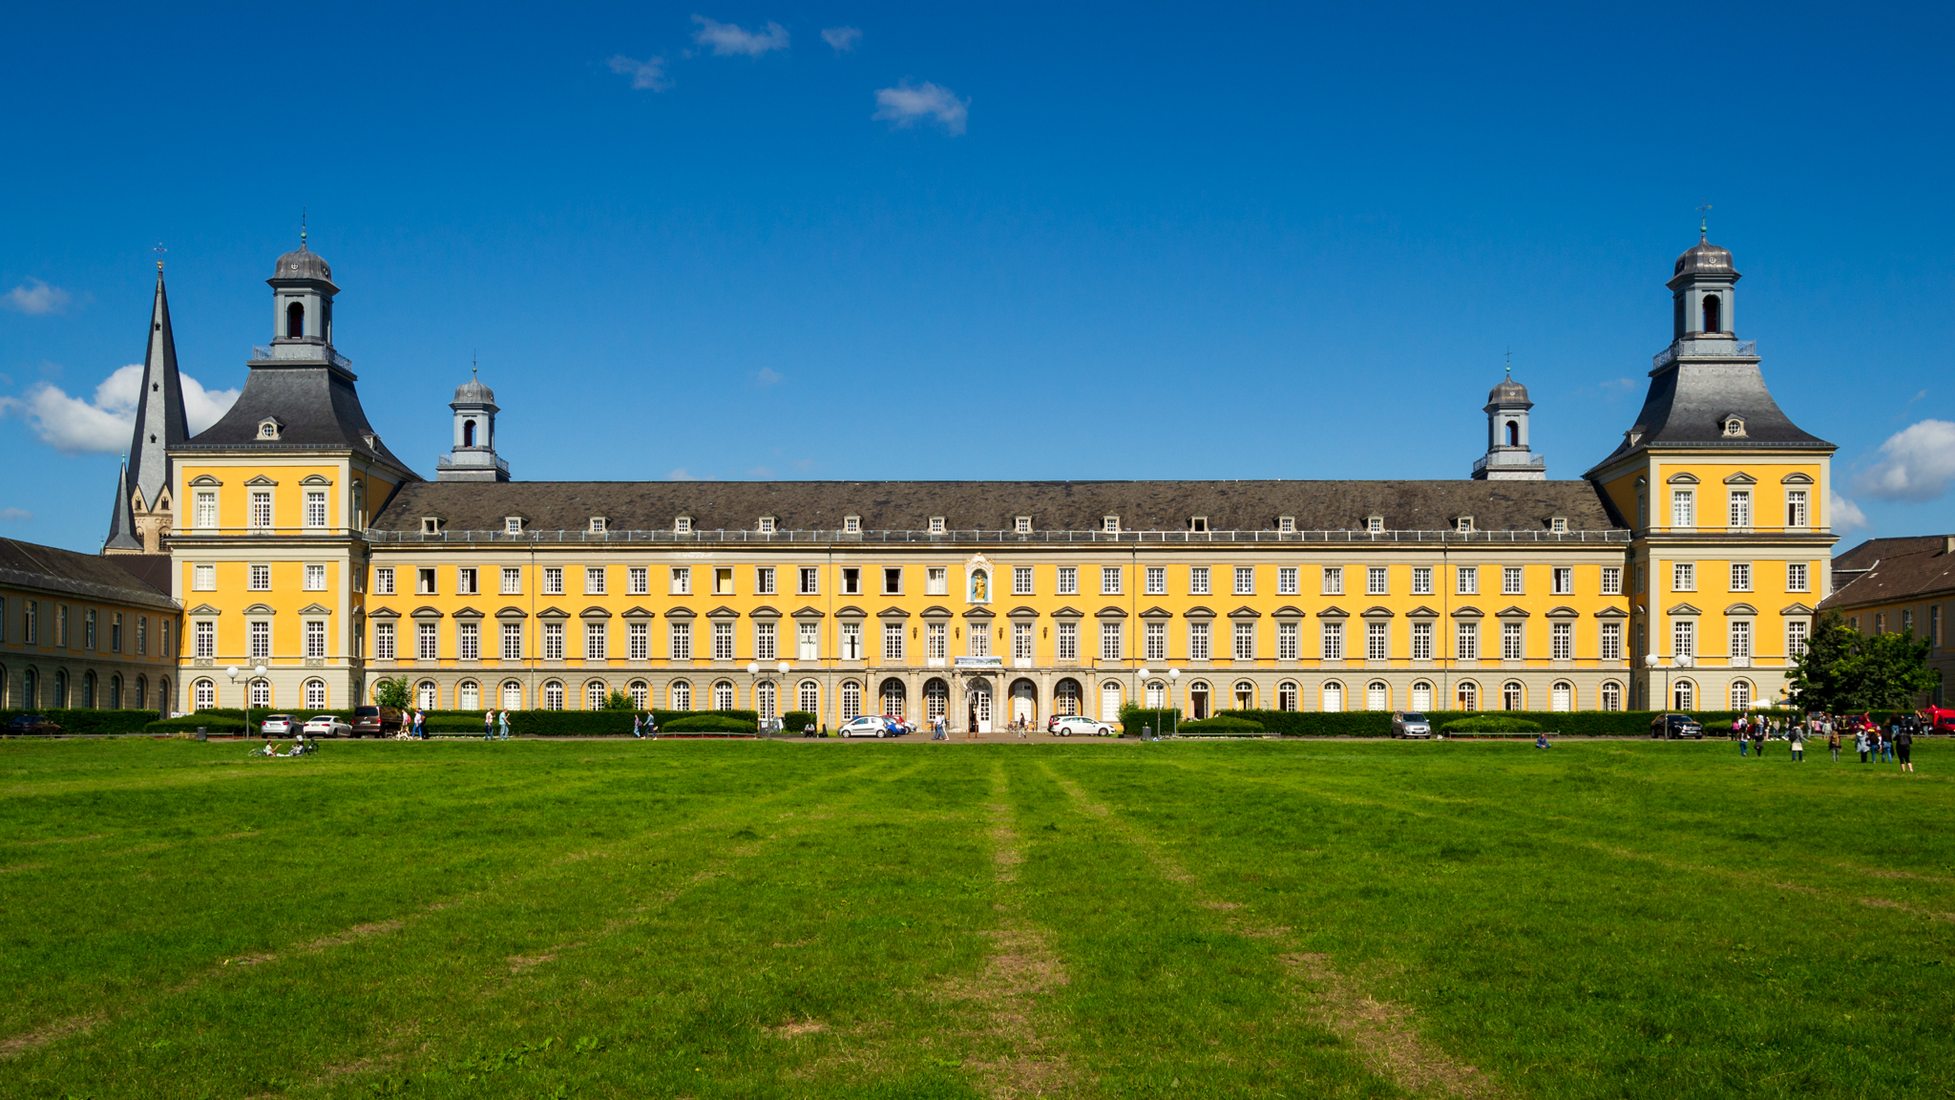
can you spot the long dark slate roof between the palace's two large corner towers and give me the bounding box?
[373,481,1627,541]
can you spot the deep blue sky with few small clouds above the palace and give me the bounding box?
[0,2,1955,549]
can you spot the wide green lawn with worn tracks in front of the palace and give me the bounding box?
[0,740,1955,1098]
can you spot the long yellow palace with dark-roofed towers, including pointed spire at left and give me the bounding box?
[80,232,1834,729]
